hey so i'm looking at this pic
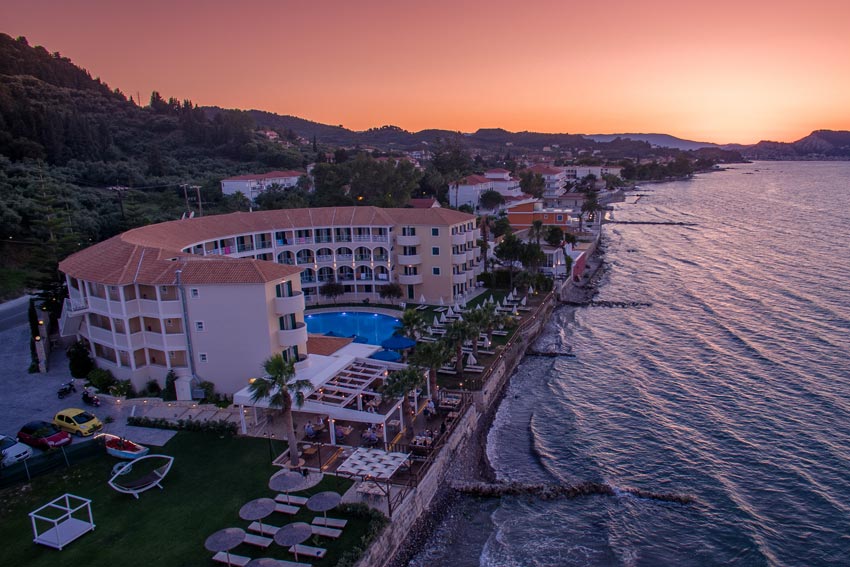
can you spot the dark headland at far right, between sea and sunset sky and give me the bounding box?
[723,130,850,160]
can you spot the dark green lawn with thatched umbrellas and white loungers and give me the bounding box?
[0,432,380,567]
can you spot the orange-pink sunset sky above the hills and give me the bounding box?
[0,0,850,143]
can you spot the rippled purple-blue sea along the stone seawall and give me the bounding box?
[410,162,850,567]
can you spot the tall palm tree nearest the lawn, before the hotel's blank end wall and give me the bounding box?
[248,353,312,467]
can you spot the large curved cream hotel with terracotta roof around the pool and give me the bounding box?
[59,207,482,399]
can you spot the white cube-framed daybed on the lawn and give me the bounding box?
[29,494,94,551]
